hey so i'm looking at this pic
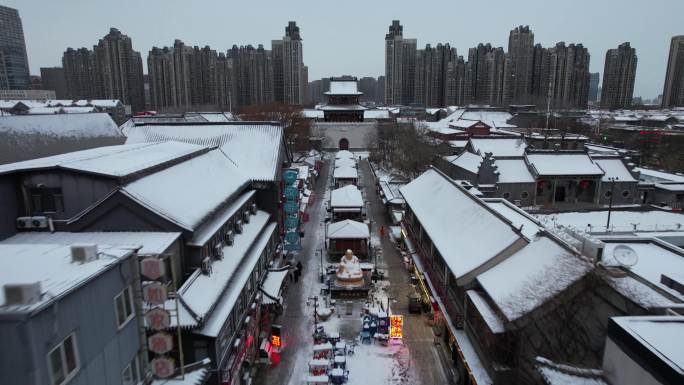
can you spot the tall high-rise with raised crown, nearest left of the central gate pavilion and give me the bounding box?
[271,21,304,104]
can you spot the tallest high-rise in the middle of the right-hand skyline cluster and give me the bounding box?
[503,26,534,104]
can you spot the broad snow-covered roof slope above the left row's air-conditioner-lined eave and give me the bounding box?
[121,148,249,230]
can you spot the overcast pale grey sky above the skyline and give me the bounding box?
[6,0,684,98]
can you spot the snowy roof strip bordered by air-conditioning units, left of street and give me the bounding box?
[178,211,269,327]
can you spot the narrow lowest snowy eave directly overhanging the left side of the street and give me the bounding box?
[197,219,277,337]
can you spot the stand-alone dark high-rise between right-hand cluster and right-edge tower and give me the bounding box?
[601,42,637,109]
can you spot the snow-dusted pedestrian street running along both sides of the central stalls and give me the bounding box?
[255,154,449,385]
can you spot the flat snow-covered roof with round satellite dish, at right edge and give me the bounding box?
[602,238,684,301]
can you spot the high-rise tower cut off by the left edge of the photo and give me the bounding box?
[0,6,31,90]
